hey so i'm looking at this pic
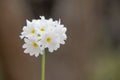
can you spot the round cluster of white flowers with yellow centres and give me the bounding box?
[20,16,67,57]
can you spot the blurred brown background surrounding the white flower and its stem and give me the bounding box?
[0,0,120,80]
